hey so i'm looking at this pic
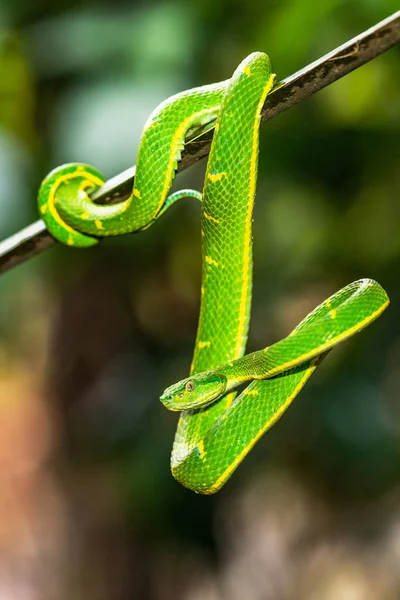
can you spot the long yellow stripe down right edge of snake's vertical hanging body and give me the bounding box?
[235,75,275,357]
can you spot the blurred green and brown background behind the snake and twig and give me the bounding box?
[0,0,400,600]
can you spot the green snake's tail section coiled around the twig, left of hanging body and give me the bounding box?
[38,81,228,247]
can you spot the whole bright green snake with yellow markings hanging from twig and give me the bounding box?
[38,52,389,494]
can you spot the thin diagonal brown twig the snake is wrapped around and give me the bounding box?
[0,11,400,273]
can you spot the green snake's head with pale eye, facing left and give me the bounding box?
[160,371,227,411]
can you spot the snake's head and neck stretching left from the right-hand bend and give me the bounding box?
[161,279,389,410]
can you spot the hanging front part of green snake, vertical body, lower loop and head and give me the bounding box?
[161,54,388,494]
